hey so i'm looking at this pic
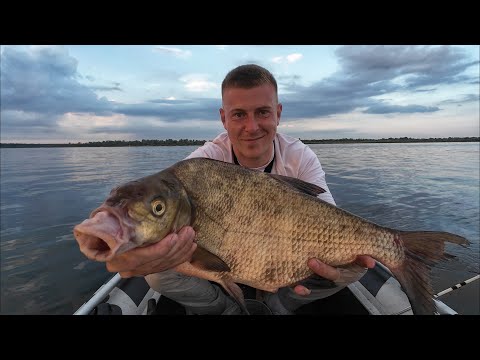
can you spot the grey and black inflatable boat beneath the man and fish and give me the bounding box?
[74,262,478,315]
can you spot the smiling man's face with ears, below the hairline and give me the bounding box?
[220,84,282,166]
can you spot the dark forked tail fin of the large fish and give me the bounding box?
[391,231,469,315]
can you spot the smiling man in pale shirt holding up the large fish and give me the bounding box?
[107,64,375,314]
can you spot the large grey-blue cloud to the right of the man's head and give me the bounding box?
[281,46,478,118]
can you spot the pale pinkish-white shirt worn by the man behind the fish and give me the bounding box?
[187,132,336,205]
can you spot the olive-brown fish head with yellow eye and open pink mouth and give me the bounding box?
[73,171,193,261]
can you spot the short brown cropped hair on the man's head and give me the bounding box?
[222,64,278,100]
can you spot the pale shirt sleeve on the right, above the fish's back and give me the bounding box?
[298,146,337,206]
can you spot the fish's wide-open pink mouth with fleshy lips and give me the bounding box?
[73,206,137,262]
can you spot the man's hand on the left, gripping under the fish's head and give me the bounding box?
[106,226,197,278]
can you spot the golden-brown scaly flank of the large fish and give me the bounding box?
[174,162,400,288]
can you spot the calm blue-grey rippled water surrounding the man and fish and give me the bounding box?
[0,143,480,315]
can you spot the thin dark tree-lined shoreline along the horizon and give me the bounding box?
[0,137,480,148]
